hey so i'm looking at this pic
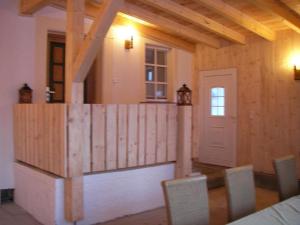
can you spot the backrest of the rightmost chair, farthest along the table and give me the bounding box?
[273,155,299,201]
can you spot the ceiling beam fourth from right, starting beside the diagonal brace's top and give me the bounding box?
[122,3,221,48]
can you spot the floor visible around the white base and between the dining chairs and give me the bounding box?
[0,187,278,225]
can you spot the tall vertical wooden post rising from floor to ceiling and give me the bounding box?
[64,0,85,222]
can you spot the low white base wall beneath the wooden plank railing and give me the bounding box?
[15,163,175,225]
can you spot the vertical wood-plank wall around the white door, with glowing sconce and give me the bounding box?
[194,31,300,177]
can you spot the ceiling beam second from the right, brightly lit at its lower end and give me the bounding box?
[194,0,275,41]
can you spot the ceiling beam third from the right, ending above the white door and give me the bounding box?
[139,0,246,44]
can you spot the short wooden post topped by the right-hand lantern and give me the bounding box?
[175,106,192,178]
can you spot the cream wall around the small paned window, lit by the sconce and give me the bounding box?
[96,27,193,104]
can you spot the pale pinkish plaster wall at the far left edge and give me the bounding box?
[0,0,35,189]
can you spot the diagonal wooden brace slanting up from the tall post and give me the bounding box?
[73,0,124,82]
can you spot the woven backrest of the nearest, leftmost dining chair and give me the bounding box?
[162,176,209,225]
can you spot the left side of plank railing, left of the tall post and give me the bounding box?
[14,104,67,177]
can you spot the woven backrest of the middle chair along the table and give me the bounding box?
[225,166,256,221]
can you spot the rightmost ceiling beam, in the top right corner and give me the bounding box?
[248,0,300,33]
